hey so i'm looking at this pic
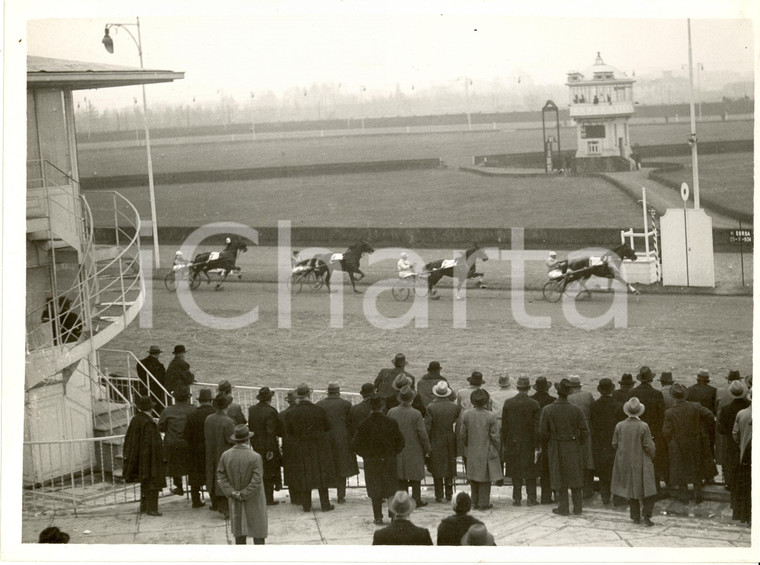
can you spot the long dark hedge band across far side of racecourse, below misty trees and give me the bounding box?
[77,98,754,142]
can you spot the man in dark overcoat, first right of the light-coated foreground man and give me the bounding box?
[249,386,282,506]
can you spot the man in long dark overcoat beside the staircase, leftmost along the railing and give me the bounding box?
[123,396,166,516]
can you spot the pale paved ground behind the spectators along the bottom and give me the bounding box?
[22,486,757,548]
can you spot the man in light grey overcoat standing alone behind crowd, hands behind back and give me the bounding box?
[216,424,268,545]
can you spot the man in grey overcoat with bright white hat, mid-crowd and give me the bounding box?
[425,380,459,502]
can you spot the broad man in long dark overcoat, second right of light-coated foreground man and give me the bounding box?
[285,384,335,512]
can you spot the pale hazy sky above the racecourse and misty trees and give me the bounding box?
[14,0,756,105]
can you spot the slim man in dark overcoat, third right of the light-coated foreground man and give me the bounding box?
[317,382,359,504]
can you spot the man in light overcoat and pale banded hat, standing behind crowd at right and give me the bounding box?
[612,396,657,526]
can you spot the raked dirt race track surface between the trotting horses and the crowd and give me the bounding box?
[108,280,752,392]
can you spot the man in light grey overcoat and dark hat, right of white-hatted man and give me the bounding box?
[459,389,504,510]
